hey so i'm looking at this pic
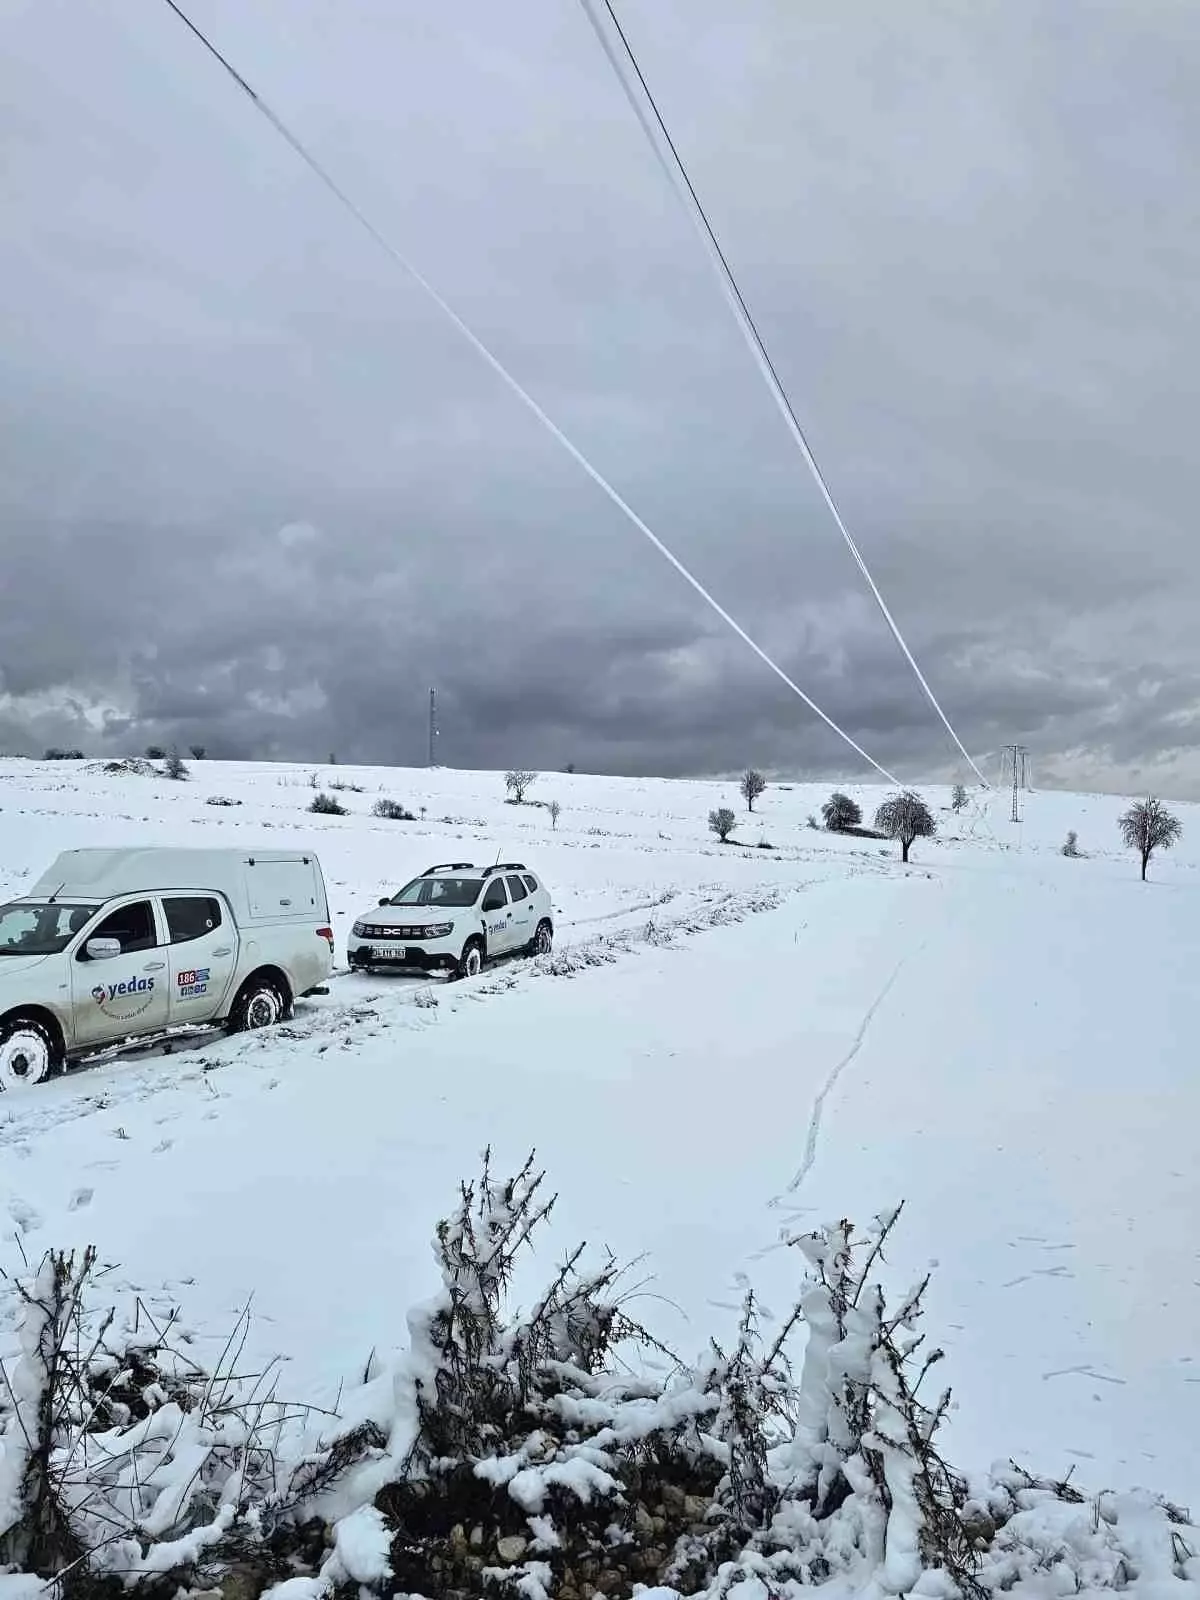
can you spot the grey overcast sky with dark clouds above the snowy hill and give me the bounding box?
[0,0,1200,797]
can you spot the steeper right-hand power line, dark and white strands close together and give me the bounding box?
[581,0,987,787]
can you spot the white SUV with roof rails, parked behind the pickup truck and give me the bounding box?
[346,861,554,978]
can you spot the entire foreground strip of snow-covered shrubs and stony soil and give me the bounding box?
[0,1157,1200,1600]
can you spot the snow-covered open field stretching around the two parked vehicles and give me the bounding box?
[0,762,1200,1509]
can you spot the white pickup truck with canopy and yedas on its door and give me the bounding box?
[0,850,333,1090]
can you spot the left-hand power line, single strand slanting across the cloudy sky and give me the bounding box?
[157,0,899,784]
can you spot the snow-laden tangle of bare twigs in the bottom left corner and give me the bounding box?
[0,1250,384,1600]
